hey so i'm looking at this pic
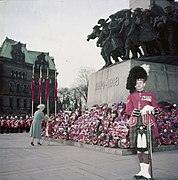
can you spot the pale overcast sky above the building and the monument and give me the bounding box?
[0,0,129,88]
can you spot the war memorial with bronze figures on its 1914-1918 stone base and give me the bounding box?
[87,1,178,107]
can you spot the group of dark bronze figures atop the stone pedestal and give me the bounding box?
[87,2,178,67]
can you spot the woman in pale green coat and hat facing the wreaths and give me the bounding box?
[30,104,49,146]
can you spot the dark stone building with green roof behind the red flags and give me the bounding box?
[0,37,56,115]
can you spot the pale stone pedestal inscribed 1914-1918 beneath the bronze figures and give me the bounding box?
[87,57,178,107]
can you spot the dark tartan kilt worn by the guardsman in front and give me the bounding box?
[129,116,157,148]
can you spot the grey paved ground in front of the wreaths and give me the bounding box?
[0,133,178,180]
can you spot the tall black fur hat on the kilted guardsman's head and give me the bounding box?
[126,66,147,93]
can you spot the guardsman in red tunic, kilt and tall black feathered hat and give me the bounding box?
[126,66,159,179]
